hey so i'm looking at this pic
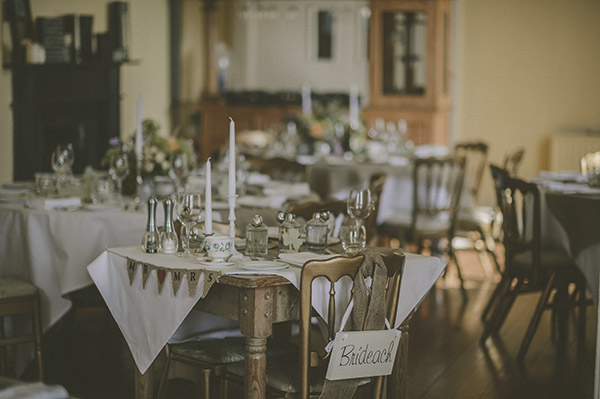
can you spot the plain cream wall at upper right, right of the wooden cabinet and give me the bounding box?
[454,0,600,203]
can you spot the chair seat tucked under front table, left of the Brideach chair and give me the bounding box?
[170,337,297,365]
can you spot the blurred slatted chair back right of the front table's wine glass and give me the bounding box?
[411,156,465,236]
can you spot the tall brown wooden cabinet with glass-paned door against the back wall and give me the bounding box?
[364,0,450,144]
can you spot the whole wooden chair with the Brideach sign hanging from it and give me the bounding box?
[227,250,405,399]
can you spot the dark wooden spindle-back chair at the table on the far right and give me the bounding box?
[481,170,587,362]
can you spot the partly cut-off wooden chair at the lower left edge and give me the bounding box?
[0,276,44,380]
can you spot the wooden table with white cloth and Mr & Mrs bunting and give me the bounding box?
[88,247,445,399]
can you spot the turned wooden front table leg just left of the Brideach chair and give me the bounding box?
[240,287,273,399]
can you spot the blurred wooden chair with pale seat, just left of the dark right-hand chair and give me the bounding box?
[453,142,502,273]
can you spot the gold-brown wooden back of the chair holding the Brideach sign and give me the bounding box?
[299,249,405,398]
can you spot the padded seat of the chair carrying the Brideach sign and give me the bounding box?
[227,349,371,394]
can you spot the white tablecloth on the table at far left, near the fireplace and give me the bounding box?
[0,204,146,330]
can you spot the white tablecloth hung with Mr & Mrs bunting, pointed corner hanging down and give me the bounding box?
[88,247,445,373]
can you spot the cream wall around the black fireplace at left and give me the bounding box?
[0,0,170,182]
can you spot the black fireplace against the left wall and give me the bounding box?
[12,63,120,181]
